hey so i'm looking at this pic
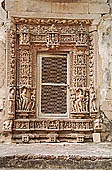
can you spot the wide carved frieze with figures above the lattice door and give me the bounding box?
[15,18,91,49]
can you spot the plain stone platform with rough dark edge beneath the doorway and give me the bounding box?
[0,143,112,170]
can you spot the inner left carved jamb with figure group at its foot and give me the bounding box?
[16,25,36,118]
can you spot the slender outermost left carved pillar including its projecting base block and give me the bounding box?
[3,21,16,135]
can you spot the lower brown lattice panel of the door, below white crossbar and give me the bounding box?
[41,85,67,114]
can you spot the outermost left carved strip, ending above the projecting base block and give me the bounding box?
[7,23,16,119]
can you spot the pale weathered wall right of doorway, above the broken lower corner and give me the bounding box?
[98,17,112,115]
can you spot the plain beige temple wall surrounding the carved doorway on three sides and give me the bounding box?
[0,0,112,142]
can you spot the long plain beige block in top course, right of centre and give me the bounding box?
[52,3,88,14]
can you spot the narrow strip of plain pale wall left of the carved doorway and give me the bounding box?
[0,1,6,141]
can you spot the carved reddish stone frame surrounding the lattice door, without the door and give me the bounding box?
[4,17,100,142]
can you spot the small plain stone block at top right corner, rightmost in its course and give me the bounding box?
[89,3,109,14]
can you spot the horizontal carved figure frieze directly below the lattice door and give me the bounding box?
[13,119,93,131]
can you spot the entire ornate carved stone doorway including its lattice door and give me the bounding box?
[5,18,100,143]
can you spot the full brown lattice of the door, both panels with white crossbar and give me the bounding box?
[41,56,67,114]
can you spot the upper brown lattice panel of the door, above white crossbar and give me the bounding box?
[42,57,67,84]
